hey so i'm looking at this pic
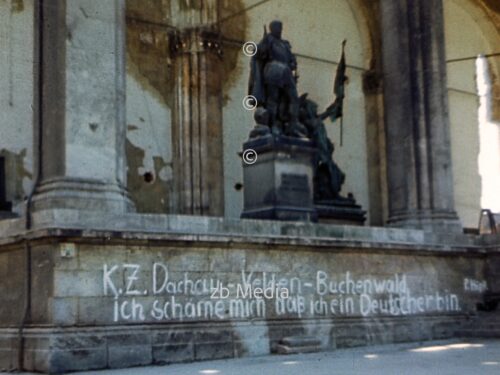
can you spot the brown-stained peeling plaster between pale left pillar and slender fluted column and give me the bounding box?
[126,0,174,213]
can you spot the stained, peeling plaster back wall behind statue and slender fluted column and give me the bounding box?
[127,0,369,217]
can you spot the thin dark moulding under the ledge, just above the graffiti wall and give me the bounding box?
[0,228,488,256]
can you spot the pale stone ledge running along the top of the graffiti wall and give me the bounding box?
[0,209,500,251]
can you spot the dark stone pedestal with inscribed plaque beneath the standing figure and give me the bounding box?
[241,135,317,221]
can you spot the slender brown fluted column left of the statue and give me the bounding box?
[170,0,224,216]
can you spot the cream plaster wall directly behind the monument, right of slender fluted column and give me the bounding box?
[223,0,381,220]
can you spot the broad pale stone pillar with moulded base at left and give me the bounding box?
[33,0,132,212]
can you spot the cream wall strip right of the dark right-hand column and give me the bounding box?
[444,0,500,228]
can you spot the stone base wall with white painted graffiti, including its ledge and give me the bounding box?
[0,216,496,372]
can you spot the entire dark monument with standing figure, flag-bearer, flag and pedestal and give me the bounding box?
[241,21,365,224]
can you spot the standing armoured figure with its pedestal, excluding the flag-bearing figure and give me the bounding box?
[241,21,316,221]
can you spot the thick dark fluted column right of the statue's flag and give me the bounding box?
[381,0,460,230]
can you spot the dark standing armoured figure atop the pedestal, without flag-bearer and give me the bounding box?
[248,21,307,137]
